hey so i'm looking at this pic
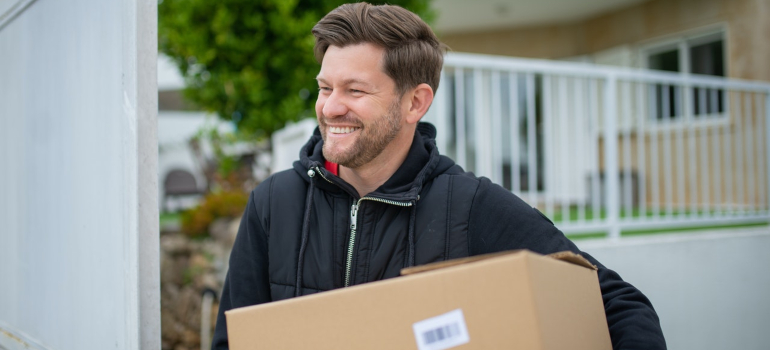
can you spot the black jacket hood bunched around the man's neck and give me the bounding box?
[294,122,455,201]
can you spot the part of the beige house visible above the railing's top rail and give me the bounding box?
[434,0,770,81]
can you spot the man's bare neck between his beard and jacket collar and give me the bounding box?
[339,129,414,197]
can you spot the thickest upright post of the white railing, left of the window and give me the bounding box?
[604,73,620,239]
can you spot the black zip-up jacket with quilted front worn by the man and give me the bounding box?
[212,123,666,350]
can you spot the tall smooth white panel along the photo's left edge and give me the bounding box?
[0,0,160,349]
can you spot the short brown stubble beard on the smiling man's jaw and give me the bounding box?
[321,102,401,169]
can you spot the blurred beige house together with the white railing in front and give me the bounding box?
[414,0,770,235]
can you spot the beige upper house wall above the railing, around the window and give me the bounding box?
[439,0,770,81]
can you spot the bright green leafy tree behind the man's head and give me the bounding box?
[158,0,432,137]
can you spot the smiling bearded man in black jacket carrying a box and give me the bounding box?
[213,3,666,350]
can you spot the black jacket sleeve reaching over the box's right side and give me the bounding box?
[468,178,666,350]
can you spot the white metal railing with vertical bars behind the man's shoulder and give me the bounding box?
[426,53,770,237]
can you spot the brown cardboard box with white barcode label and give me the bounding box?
[225,251,612,350]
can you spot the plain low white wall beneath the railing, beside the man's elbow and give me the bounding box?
[577,226,770,350]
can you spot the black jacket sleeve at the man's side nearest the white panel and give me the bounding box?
[211,182,272,350]
